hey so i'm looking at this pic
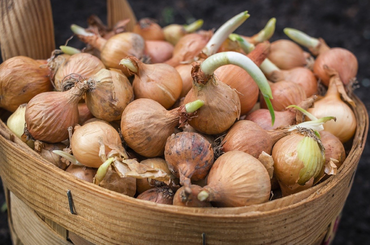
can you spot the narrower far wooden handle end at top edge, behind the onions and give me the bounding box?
[107,0,137,31]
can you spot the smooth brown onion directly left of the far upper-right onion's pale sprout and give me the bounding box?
[267,39,307,70]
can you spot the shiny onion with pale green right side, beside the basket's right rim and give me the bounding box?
[272,128,325,196]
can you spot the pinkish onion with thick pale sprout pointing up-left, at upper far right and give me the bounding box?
[284,28,358,86]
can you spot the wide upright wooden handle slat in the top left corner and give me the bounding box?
[0,0,55,60]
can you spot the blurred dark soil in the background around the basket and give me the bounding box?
[0,0,370,245]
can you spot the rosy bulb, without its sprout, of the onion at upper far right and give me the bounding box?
[313,48,358,86]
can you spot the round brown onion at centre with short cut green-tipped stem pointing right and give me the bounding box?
[121,98,203,157]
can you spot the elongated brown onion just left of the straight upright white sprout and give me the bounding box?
[165,31,213,67]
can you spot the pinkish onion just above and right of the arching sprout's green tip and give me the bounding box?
[260,80,307,111]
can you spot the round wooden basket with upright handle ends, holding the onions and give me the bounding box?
[0,0,369,245]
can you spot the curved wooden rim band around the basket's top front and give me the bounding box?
[0,97,369,244]
